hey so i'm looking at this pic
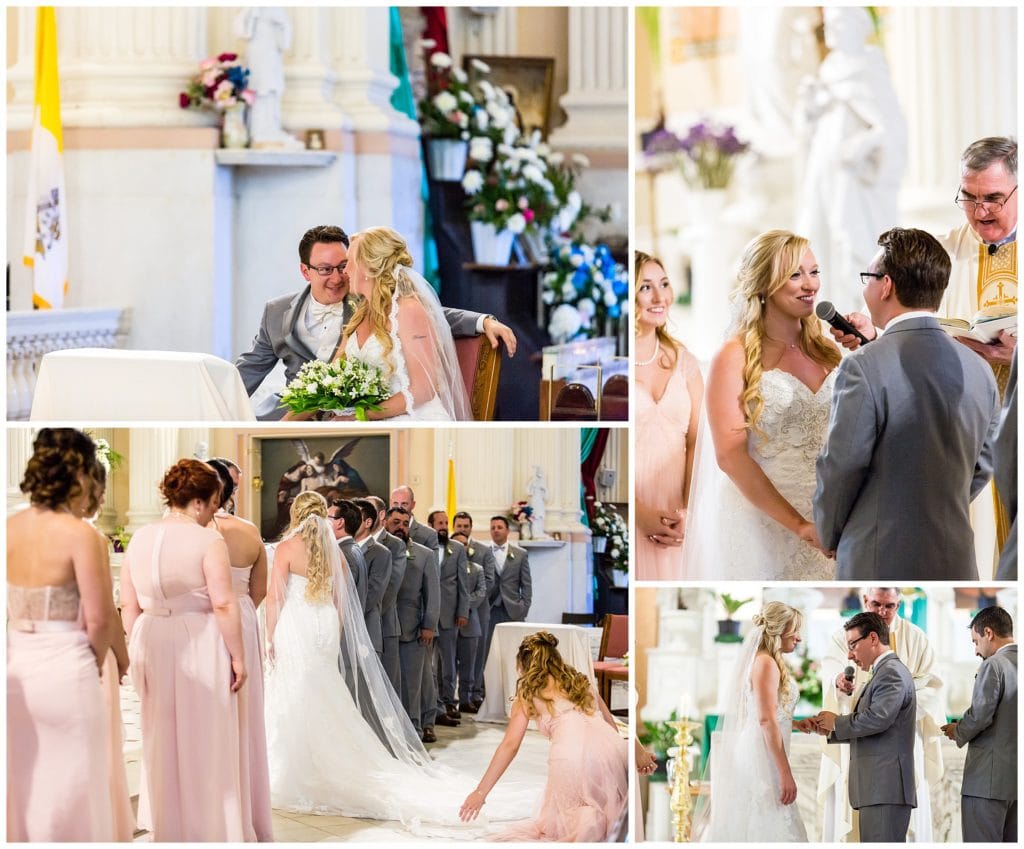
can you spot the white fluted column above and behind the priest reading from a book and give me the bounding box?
[883,6,1018,223]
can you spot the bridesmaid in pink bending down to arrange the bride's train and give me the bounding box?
[459,631,629,843]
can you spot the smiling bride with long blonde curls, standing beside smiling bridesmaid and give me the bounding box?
[683,230,840,581]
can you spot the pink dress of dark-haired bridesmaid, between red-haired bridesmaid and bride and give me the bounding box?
[231,566,273,843]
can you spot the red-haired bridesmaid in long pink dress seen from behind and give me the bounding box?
[121,460,247,842]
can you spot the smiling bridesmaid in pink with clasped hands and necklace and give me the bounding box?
[635,251,703,581]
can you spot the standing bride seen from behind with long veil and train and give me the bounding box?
[265,492,536,833]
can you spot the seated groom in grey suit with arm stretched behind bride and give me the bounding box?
[234,224,516,420]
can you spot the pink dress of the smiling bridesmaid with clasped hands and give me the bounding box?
[636,348,700,581]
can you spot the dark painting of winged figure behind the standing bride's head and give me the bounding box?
[254,433,391,540]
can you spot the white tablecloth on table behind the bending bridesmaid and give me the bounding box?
[475,622,596,722]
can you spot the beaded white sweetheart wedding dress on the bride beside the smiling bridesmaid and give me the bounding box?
[683,369,836,581]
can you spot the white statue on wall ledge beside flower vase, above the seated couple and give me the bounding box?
[234,6,305,150]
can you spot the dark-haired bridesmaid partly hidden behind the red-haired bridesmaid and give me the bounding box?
[207,460,273,843]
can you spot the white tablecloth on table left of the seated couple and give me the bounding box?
[31,348,255,422]
